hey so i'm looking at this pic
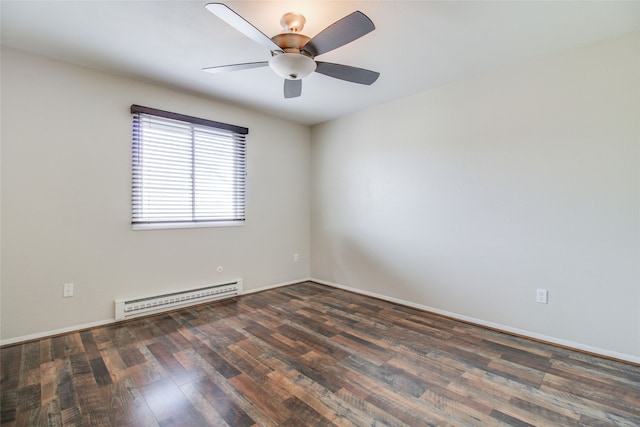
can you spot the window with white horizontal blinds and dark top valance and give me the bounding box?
[131,105,249,229]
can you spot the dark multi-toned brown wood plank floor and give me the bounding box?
[1,283,640,427]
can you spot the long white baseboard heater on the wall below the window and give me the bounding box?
[115,279,242,320]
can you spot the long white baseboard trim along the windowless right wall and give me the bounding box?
[309,278,640,364]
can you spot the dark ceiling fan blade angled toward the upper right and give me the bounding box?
[302,11,376,56]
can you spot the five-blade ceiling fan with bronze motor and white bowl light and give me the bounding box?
[204,3,380,98]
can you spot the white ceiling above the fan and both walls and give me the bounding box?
[0,0,640,124]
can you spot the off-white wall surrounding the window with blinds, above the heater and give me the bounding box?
[1,50,310,342]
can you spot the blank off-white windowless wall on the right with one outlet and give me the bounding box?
[311,34,640,361]
